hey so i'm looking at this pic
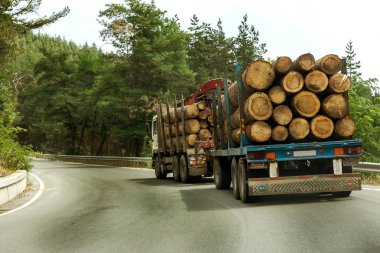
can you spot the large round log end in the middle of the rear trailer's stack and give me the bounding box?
[292,91,321,118]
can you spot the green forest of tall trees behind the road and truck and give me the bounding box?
[0,0,380,173]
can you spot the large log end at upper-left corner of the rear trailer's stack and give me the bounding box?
[242,60,275,91]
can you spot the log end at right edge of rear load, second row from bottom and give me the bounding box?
[322,94,348,119]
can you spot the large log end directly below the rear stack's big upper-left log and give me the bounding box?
[244,92,273,120]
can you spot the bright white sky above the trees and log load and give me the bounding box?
[39,0,380,79]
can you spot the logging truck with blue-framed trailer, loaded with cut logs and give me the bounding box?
[153,54,362,203]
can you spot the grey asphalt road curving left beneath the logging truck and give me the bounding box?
[0,160,380,253]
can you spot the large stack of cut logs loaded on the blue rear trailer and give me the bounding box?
[222,53,355,144]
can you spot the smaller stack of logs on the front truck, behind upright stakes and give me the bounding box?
[162,101,213,151]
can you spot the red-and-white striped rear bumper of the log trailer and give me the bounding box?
[248,173,361,196]
